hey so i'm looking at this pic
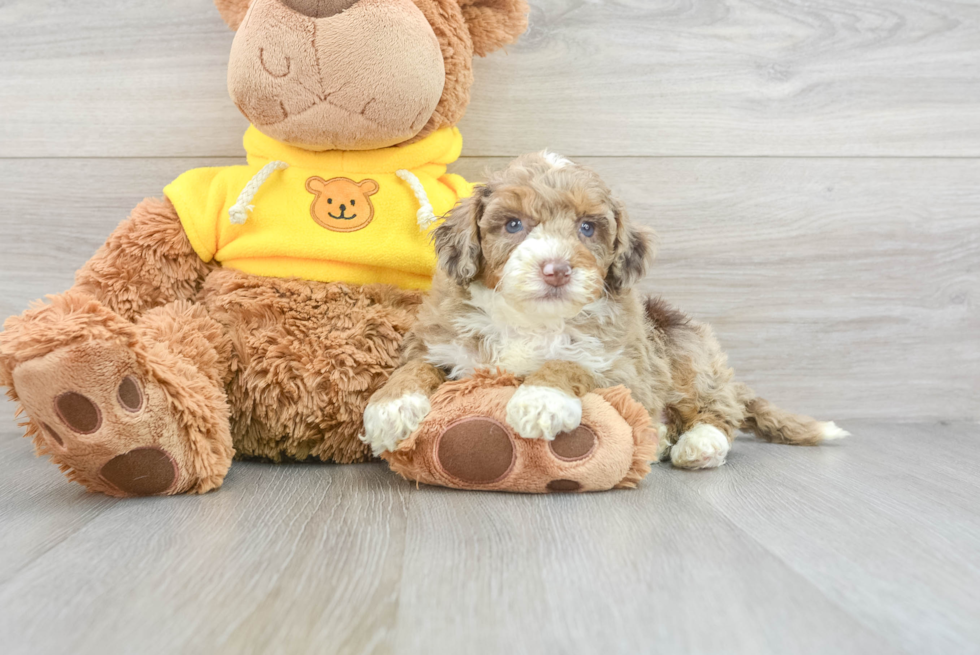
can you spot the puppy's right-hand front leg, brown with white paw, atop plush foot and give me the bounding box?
[507,361,595,441]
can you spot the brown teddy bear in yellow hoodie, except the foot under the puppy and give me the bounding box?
[0,0,527,496]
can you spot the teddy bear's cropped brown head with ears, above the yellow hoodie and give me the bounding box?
[215,0,528,150]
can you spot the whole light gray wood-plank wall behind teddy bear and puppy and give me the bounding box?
[0,0,980,421]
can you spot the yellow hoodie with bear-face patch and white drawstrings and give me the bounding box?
[164,127,472,289]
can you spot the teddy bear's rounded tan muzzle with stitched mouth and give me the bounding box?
[228,0,446,151]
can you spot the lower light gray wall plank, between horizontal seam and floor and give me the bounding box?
[0,158,980,421]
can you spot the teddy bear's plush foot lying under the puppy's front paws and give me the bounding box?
[382,373,656,493]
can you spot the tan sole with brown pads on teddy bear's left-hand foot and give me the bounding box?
[12,340,232,497]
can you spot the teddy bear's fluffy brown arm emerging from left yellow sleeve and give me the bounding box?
[73,198,214,320]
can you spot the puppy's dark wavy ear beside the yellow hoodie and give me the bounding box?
[432,186,490,285]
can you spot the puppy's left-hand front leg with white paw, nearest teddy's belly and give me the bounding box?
[361,359,446,455]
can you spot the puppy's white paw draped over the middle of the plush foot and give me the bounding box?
[507,384,582,441]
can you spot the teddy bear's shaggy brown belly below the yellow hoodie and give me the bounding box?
[201,270,421,463]
